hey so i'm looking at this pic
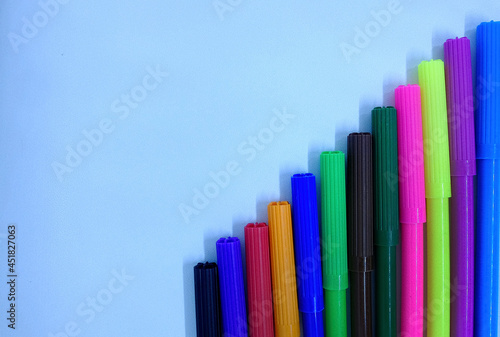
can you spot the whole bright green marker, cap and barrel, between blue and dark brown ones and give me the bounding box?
[320,151,348,337]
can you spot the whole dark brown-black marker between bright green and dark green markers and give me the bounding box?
[347,133,373,337]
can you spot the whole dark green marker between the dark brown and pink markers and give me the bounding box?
[372,107,399,337]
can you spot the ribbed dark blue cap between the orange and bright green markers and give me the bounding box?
[292,173,325,312]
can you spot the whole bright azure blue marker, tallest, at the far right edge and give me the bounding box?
[474,21,500,337]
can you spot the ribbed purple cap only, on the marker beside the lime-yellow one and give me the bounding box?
[444,37,476,176]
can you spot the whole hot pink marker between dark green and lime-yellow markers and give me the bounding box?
[395,85,426,337]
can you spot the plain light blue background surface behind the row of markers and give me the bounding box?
[0,0,500,337]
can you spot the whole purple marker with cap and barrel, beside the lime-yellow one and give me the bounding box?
[444,37,476,337]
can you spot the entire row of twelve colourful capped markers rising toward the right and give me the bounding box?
[194,21,500,337]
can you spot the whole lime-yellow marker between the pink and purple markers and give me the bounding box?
[418,60,451,337]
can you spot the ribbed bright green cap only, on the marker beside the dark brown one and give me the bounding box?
[320,151,349,290]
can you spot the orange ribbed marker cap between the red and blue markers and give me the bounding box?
[267,201,300,337]
